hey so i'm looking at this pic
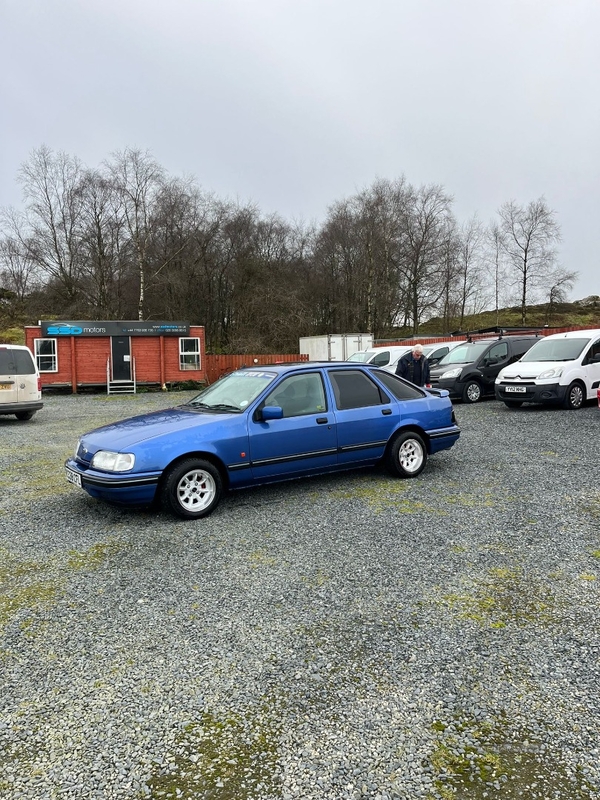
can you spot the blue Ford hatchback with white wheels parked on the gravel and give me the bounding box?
[65,362,460,519]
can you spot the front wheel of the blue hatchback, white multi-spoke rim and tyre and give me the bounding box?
[160,458,223,519]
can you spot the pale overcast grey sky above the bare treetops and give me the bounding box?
[0,0,600,299]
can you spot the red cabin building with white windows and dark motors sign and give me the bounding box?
[25,320,206,394]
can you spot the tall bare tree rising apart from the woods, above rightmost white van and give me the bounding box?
[498,197,560,324]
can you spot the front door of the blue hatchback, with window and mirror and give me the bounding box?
[249,372,337,482]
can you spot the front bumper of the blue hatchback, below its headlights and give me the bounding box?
[65,458,162,505]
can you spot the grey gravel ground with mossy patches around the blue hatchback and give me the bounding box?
[0,392,600,800]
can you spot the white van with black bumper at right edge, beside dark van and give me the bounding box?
[494,329,600,409]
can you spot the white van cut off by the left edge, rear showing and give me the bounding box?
[0,344,44,420]
